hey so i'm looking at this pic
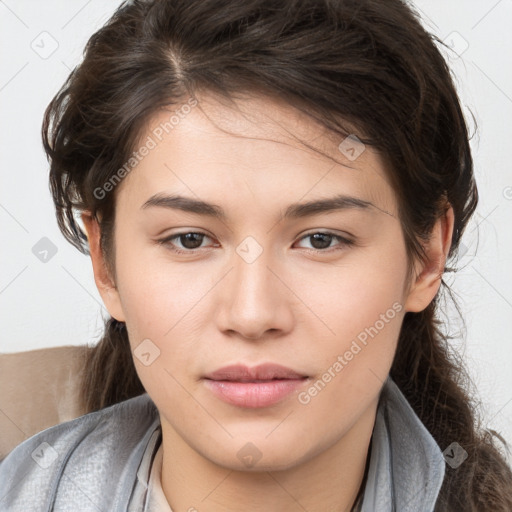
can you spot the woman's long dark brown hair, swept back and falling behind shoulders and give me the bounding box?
[42,0,512,512]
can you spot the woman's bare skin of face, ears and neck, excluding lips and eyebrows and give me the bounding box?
[83,94,453,512]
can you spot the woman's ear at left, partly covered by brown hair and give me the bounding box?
[81,212,125,322]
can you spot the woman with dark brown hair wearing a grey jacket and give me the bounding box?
[0,0,512,512]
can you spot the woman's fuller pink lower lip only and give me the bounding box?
[204,379,307,408]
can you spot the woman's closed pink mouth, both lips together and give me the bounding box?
[204,364,309,408]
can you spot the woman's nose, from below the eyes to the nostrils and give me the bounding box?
[216,244,293,340]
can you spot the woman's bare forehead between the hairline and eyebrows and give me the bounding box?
[117,94,395,216]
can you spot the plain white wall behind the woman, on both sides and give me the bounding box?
[0,0,512,452]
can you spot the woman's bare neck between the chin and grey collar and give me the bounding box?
[161,402,377,512]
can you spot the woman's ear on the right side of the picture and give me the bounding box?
[405,205,454,313]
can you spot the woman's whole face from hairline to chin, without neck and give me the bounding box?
[86,94,438,469]
